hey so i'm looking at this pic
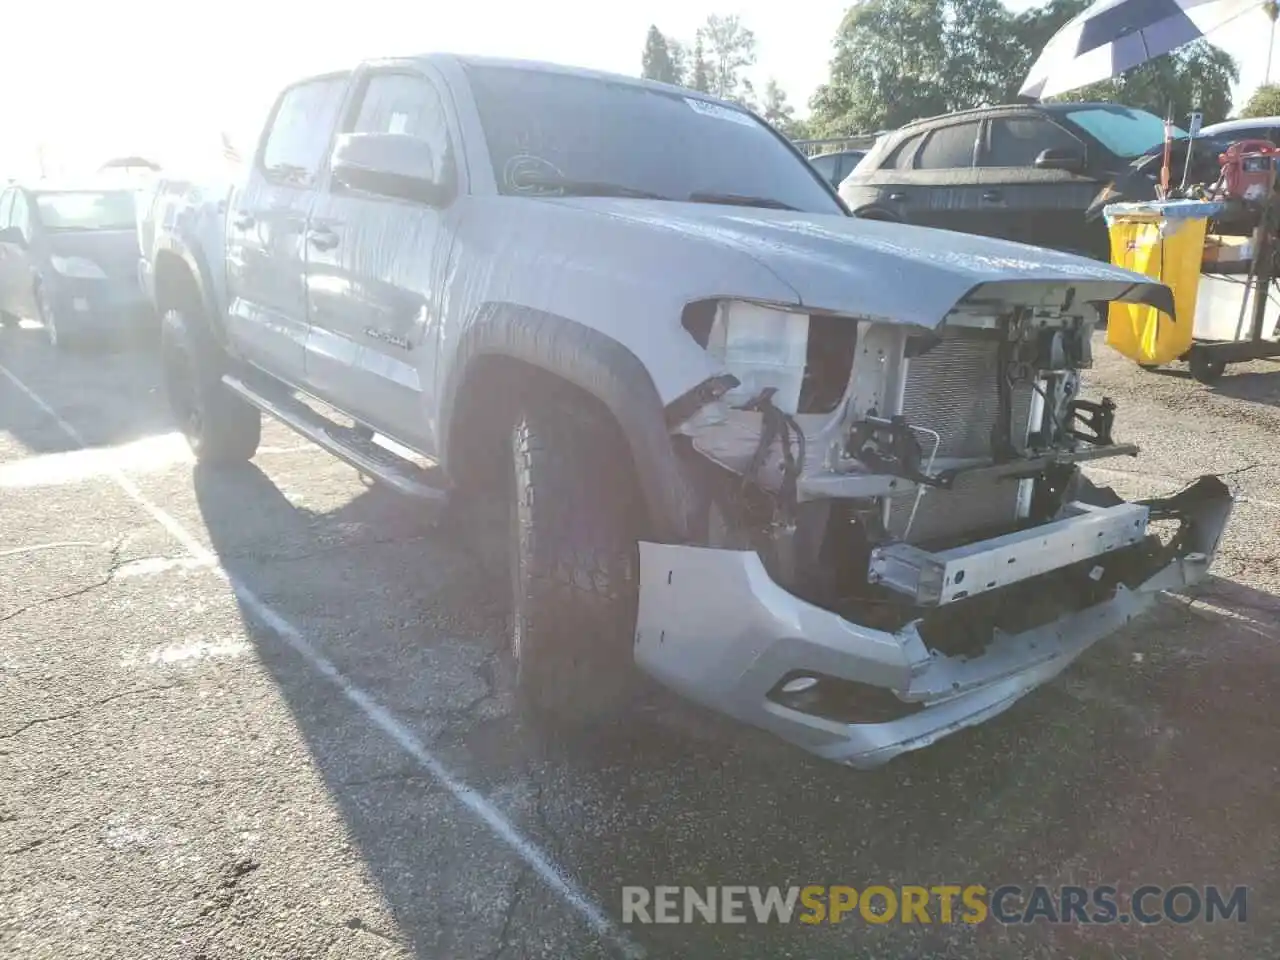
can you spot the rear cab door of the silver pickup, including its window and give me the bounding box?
[227,74,348,384]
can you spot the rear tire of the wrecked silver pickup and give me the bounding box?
[160,310,262,463]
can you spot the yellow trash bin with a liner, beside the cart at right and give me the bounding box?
[1105,200,1221,364]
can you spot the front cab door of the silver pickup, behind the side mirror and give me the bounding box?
[306,65,461,454]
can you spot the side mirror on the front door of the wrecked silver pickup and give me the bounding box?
[333,133,453,206]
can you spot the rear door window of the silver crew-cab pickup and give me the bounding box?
[261,77,347,187]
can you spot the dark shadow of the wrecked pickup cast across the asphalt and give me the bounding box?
[195,466,1280,957]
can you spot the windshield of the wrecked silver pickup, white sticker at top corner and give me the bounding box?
[467,65,844,215]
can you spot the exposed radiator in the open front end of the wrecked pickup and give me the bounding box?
[888,338,1033,543]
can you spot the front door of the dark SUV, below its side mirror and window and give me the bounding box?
[978,114,1102,252]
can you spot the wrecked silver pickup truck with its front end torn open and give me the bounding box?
[140,55,1231,767]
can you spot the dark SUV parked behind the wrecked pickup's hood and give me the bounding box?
[840,104,1185,260]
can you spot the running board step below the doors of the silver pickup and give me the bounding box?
[223,374,448,506]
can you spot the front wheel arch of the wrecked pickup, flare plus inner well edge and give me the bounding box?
[439,303,694,543]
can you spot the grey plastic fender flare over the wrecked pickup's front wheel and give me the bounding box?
[439,303,696,543]
